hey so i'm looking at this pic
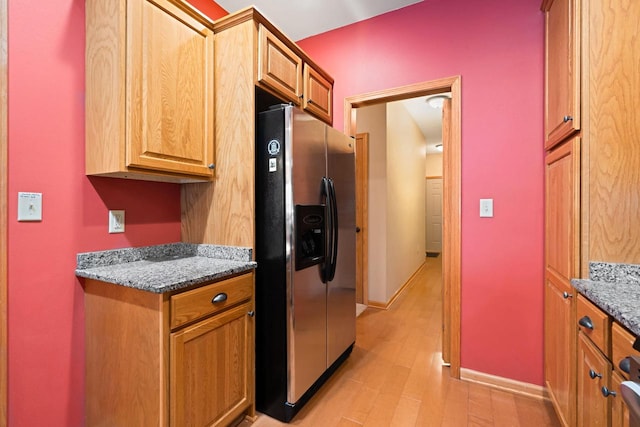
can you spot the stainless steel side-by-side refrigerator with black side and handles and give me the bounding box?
[256,105,356,422]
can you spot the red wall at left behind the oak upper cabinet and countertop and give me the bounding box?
[8,0,224,427]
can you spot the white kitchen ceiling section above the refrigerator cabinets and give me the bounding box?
[216,0,422,41]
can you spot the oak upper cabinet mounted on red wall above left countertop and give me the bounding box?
[86,0,214,182]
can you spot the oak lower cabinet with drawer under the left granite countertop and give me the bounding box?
[84,274,255,427]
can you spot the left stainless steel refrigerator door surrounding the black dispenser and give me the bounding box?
[286,107,327,403]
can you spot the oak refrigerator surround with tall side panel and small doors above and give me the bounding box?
[182,8,333,247]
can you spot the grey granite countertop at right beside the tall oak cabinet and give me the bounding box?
[571,262,640,336]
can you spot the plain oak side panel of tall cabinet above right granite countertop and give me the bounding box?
[582,0,640,270]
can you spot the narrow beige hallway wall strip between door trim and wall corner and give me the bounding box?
[356,104,387,302]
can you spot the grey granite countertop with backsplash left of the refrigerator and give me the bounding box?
[76,243,257,293]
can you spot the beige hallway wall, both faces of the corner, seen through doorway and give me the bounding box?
[356,103,426,303]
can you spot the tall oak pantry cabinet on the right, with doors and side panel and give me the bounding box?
[541,0,640,426]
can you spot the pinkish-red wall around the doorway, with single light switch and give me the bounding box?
[299,0,544,385]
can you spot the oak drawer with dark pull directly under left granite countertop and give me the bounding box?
[171,274,253,329]
